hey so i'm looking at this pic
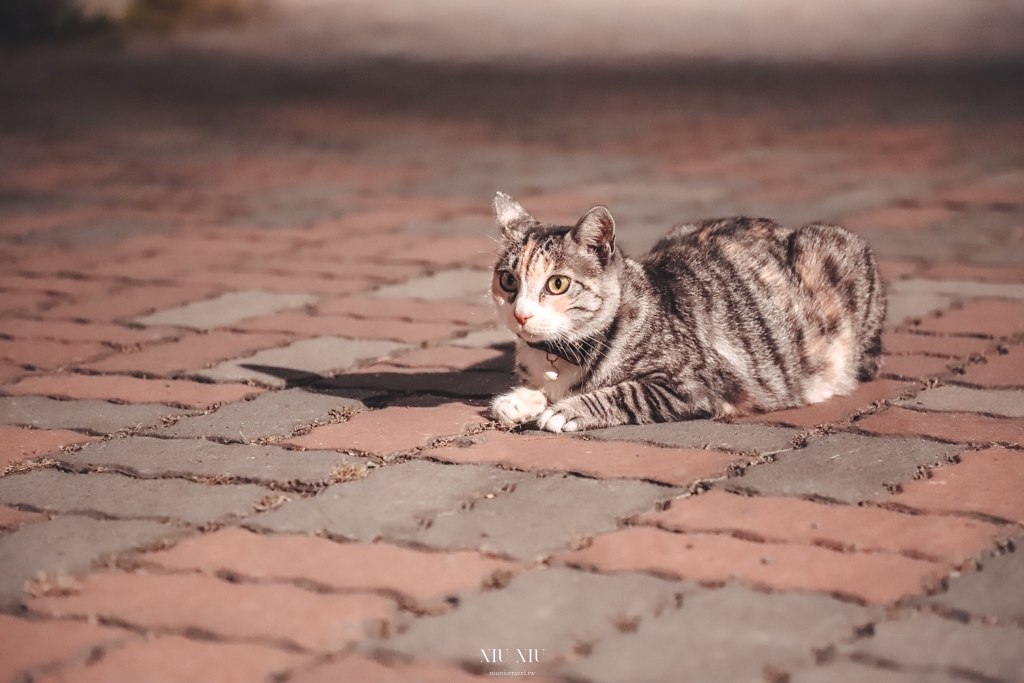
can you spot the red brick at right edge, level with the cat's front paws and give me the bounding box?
[857,407,1024,445]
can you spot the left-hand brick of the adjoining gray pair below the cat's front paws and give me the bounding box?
[247,461,531,541]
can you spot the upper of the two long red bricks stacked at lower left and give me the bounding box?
[141,528,517,600]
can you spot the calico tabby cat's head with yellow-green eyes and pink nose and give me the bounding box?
[490,193,622,342]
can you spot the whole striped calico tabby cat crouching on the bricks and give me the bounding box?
[492,193,886,432]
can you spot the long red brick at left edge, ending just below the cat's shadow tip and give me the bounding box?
[0,375,265,409]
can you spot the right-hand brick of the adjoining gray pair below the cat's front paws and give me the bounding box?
[417,474,682,560]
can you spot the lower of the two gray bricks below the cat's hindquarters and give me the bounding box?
[712,433,964,503]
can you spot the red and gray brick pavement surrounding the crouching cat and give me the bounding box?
[0,55,1024,683]
